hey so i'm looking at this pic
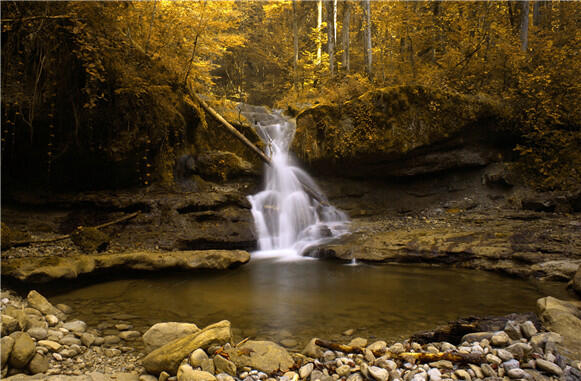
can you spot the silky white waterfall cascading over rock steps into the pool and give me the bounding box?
[242,106,349,260]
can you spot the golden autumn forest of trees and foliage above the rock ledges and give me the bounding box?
[2,0,581,190]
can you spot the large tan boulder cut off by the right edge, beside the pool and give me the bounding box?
[537,296,581,360]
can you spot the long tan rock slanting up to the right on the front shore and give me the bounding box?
[143,320,232,375]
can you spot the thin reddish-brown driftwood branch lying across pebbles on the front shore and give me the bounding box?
[315,339,486,364]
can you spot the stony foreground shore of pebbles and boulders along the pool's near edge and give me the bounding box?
[1,291,581,381]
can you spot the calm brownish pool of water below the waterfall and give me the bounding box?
[45,259,565,349]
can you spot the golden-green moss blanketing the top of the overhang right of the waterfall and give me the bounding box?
[293,86,502,161]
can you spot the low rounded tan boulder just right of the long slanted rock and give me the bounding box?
[228,340,294,373]
